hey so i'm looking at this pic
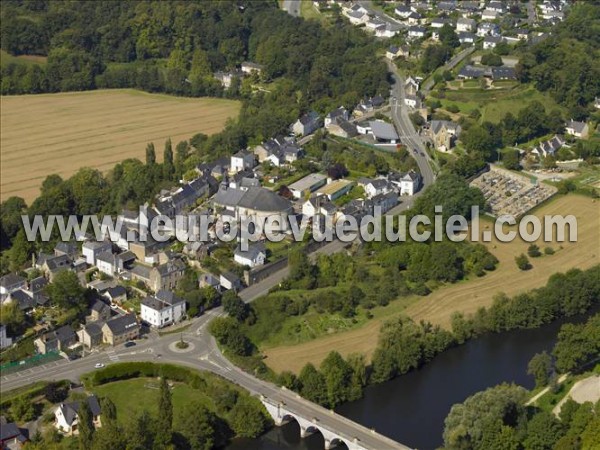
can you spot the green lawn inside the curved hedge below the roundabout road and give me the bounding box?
[92,378,214,424]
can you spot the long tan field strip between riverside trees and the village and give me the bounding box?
[263,195,600,372]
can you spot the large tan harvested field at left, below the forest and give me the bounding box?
[0,90,240,202]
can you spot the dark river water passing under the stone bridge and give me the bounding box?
[228,307,600,450]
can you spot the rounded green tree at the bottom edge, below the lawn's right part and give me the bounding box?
[178,402,217,450]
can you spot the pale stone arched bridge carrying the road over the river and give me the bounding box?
[259,391,410,450]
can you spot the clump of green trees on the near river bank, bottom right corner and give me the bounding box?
[443,384,600,450]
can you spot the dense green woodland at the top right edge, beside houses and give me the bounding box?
[516,2,600,120]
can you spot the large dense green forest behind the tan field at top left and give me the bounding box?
[1,0,389,107]
